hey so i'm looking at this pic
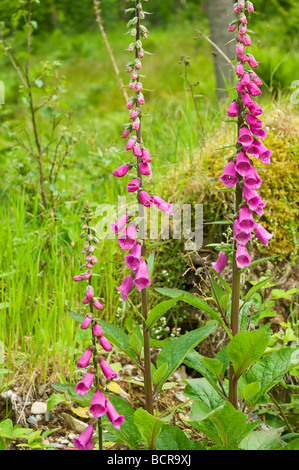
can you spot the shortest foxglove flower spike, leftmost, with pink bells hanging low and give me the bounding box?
[73,203,124,450]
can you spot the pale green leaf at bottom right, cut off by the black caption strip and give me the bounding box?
[239,429,283,450]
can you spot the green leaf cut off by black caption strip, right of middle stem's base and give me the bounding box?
[156,424,205,451]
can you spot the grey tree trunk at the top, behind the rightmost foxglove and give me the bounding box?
[207,0,236,99]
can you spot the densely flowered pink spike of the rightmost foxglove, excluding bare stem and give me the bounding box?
[221,0,273,272]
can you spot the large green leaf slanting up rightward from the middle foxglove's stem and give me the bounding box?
[157,321,217,388]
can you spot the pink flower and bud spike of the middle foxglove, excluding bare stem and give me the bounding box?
[110,0,173,301]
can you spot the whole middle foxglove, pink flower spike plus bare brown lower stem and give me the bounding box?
[111,0,172,414]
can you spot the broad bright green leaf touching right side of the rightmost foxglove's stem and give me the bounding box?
[227,330,270,377]
